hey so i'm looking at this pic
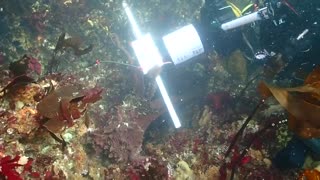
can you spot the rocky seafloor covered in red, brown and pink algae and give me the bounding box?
[0,0,320,180]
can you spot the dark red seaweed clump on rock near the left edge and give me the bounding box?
[9,55,41,77]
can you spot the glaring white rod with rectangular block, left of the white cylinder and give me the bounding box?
[122,1,181,128]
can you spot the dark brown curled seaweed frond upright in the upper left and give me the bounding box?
[54,33,93,56]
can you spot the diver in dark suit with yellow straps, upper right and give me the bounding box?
[200,0,320,67]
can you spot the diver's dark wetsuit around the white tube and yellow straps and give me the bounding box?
[201,0,320,69]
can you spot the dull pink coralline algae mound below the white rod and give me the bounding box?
[90,106,160,163]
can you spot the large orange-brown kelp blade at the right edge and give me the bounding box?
[259,67,320,138]
